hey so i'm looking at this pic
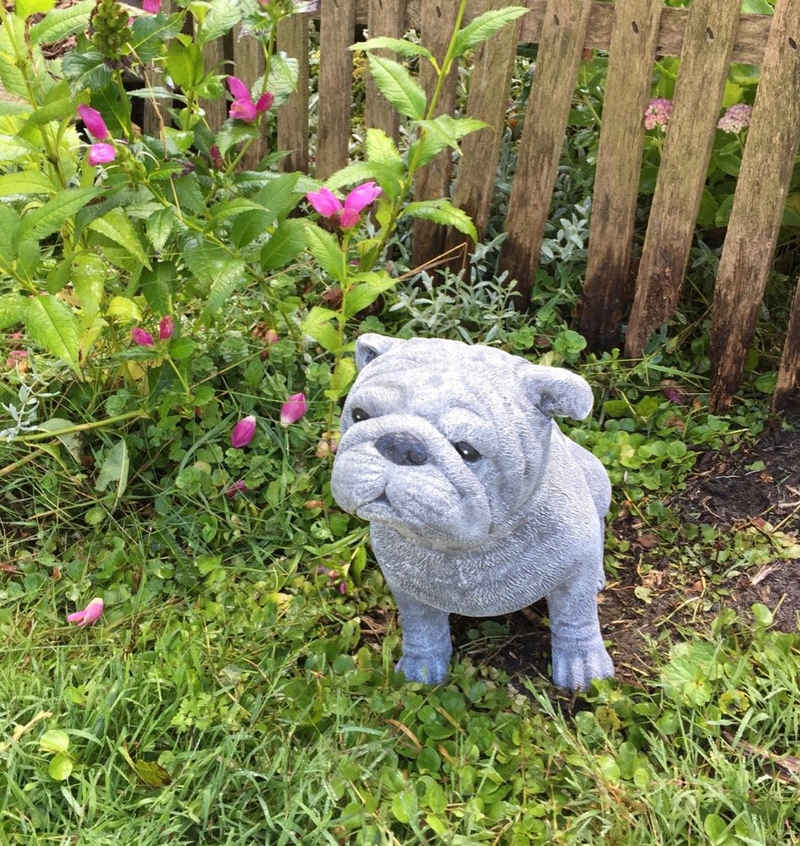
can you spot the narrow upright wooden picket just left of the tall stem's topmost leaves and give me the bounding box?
[316,0,356,179]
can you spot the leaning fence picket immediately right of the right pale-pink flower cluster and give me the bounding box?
[711,0,800,409]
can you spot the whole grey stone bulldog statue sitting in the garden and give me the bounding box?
[332,333,614,689]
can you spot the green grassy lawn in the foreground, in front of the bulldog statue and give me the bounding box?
[0,528,800,846]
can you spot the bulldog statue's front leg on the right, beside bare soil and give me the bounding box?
[547,568,614,690]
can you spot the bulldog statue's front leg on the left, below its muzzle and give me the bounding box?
[390,585,453,684]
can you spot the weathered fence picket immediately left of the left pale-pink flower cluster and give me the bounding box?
[580,0,664,350]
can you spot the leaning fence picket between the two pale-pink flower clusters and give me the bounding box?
[625,0,739,358]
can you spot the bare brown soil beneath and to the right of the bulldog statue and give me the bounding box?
[452,428,800,684]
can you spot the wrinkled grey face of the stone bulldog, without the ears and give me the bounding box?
[332,339,551,550]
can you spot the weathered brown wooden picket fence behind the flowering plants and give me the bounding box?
[191,0,800,409]
